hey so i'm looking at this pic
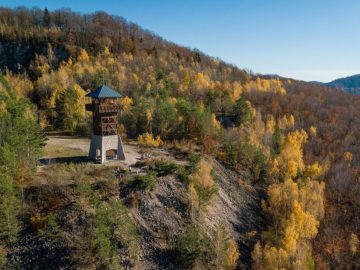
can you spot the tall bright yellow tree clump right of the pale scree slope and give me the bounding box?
[258,138,325,269]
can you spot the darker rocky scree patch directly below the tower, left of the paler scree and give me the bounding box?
[131,176,191,269]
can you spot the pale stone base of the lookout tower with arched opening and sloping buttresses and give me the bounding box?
[89,135,125,163]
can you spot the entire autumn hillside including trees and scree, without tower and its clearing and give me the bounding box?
[0,8,360,269]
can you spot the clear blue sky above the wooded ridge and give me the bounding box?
[0,0,360,82]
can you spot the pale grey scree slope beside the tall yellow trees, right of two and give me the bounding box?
[204,161,265,269]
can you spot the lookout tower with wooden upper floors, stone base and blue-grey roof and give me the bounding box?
[85,85,125,163]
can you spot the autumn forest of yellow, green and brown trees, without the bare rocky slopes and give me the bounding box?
[0,8,360,269]
